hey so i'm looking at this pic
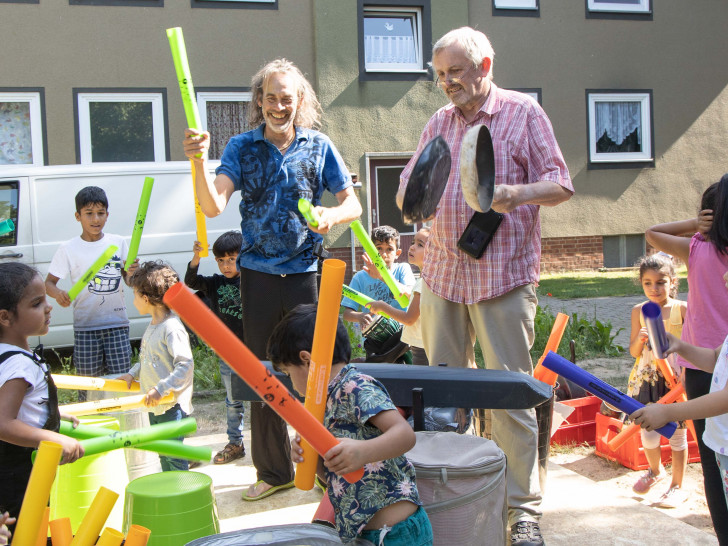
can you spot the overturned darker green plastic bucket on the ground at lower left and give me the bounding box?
[123,471,220,546]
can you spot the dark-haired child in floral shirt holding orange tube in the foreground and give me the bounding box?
[268,305,432,546]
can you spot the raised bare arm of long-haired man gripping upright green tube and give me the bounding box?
[182,129,235,218]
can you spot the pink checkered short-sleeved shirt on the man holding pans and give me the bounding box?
[400,84,574,304]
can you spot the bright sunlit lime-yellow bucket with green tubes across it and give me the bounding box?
[50,415,129,534]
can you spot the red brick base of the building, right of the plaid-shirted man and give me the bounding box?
[541,235,604,272]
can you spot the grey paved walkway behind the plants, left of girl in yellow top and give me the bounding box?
[538,292,688,349]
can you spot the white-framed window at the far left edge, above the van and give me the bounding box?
[0,88,45,165]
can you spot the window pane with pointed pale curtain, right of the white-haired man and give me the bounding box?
[594,102,642,153]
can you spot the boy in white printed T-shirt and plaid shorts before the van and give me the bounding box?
[45,186,138,400]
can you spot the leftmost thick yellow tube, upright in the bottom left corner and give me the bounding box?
[13,441,63,546]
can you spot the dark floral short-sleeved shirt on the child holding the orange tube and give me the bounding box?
[324,364,422,543]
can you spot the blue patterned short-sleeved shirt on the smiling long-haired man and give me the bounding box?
[215,124,352,275]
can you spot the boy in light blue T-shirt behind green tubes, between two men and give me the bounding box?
[341,226,415,362]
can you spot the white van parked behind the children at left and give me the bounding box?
[0,161,240,347]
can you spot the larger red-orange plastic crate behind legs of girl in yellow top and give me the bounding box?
[595,413,700,470]
